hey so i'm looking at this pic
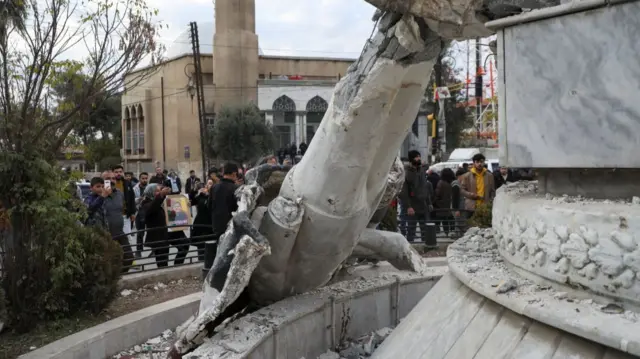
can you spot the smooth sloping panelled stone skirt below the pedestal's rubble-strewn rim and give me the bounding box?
[372,274,634,359]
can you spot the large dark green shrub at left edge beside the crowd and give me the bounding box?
[0,153,122,332]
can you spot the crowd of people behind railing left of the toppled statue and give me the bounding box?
[84,163,242,272]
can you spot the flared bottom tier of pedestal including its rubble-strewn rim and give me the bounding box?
[373,230,640,359]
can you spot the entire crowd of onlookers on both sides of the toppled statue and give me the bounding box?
[75,148,520,271]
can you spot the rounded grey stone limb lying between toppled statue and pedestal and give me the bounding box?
[352,228,427,273]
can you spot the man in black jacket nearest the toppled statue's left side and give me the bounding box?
[209,163,238,240]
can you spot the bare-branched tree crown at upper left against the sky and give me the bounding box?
[0,0,163,154]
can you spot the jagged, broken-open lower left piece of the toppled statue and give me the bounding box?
[168,211,271,359]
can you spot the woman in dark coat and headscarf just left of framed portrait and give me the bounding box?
[141,183,171,268]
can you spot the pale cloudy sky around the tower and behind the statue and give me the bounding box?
[147,0,496,94]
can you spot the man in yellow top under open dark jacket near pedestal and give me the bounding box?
[460,153,496,217]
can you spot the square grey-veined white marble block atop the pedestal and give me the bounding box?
[487,0,640,168]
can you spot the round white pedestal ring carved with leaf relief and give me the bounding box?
[493,182,640,311]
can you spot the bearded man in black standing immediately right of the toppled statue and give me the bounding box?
[399,150,433,246]
